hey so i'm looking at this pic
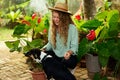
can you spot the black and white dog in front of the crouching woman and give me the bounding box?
[25,49,76,80]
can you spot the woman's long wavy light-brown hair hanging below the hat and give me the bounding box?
[51,11,73,48]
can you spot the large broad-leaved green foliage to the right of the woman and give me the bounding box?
[74,6,120,79]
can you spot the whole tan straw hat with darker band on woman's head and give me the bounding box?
[49,3,72,14]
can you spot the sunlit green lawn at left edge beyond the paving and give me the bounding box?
[0,27,14,41]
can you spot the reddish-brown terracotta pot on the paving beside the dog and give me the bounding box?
[31,71,47,80]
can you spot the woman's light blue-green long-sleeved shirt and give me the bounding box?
[44,24,78,57]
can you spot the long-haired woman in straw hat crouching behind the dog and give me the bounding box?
[43,3,78,79]
